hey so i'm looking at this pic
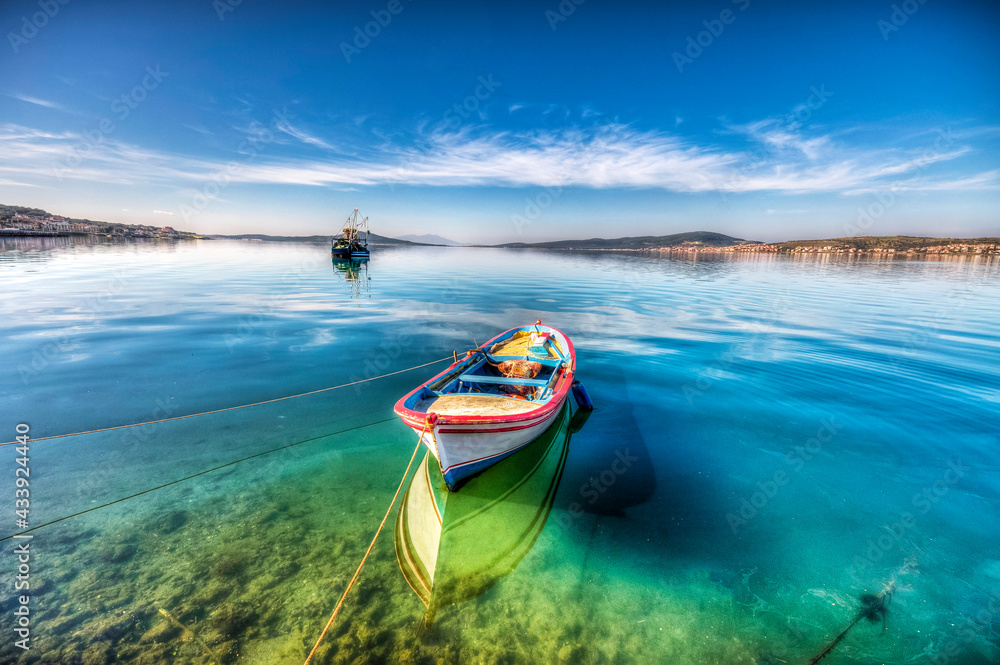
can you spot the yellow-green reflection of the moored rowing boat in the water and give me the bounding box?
[396,400,590,626]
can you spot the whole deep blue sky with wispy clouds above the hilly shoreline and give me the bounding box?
[0,0,1000,243]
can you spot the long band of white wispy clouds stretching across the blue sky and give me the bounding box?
[0,121,1000,194]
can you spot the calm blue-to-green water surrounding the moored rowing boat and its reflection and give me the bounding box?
[0,239,1000,664]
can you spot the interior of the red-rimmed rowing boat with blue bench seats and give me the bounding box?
[413,330,569,415]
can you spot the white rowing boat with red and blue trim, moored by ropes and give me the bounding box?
[395,319,589,491]
